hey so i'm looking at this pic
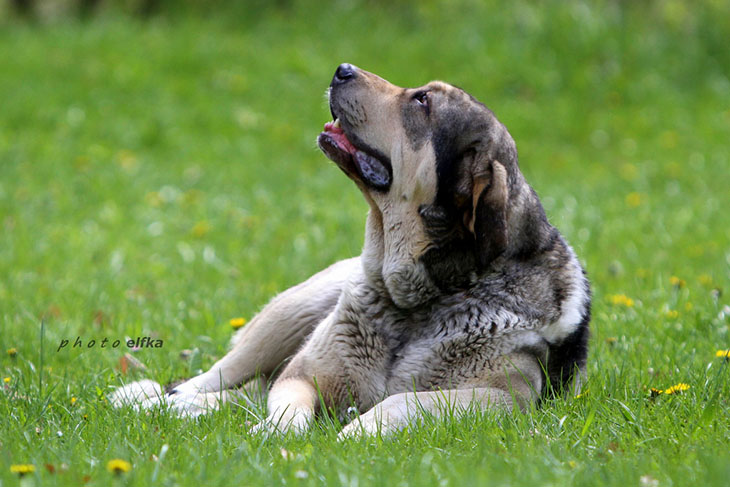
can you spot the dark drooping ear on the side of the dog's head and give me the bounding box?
[467,158,509,269]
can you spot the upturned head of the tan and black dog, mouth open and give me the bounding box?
[318,64,548,308]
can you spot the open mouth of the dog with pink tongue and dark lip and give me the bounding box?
[317,118,392,190]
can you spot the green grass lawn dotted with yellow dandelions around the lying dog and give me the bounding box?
[0,1,730,487]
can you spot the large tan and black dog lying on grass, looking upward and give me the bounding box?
[112,64,590,435]
